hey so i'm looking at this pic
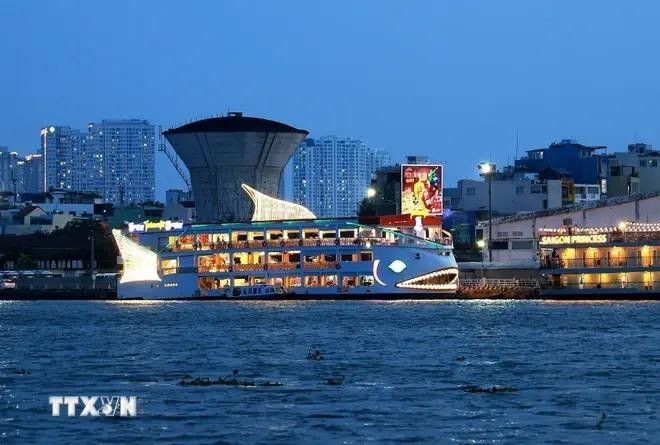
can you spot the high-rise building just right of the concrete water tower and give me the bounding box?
[292,136,390,217]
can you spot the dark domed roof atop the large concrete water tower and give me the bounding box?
[163,112,309,136]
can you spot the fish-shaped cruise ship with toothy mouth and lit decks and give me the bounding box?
[113,185,458,299]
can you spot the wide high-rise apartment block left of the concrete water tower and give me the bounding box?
[41,119,155,205]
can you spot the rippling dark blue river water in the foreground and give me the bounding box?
[0,301,660,444]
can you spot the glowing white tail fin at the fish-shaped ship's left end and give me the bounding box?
[112,229,160,283]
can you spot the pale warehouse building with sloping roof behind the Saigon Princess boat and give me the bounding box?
[483,192,660,264]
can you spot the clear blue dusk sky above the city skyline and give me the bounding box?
[0,0,660,199]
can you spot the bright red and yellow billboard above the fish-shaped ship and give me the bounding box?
[401,164,442,216]
